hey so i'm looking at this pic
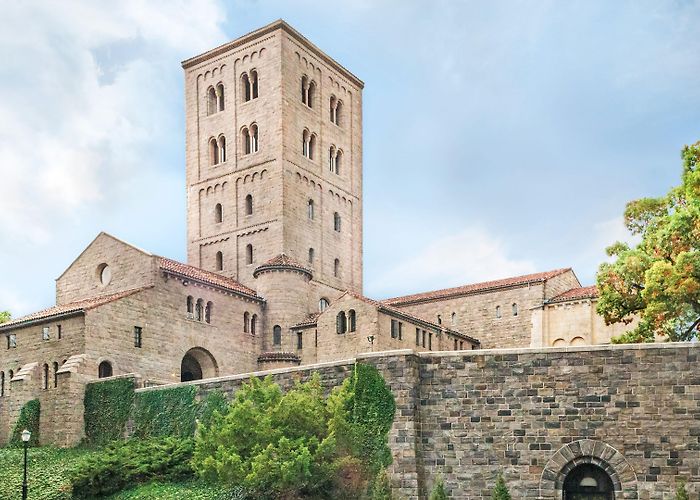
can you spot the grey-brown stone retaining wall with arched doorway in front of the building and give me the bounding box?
[133,343,700,500]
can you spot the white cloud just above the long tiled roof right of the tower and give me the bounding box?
[367,227,535,296]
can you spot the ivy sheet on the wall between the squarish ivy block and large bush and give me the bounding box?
[133,386,228,438]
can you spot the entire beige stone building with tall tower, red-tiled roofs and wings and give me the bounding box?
[0,21,636,454]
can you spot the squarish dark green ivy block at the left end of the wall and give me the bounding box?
[84,378,134,445]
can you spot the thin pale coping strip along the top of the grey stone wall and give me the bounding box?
[131,342,700,392]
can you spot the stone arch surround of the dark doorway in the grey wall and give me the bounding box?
[539,439,639,500]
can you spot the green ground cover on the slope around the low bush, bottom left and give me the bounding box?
[0,447,223,500]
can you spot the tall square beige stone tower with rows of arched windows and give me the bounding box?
[182,21,363,292]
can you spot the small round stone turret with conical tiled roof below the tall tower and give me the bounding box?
[253,254,313,370]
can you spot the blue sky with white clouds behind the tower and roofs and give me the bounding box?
[0,0,700,317]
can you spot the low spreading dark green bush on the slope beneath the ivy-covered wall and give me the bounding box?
[71,437,194,498]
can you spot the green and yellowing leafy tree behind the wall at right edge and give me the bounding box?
[597,141,700,343]
